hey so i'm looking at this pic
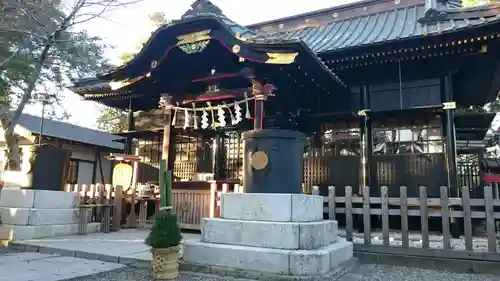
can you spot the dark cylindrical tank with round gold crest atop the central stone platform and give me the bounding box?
[242,129,305,194]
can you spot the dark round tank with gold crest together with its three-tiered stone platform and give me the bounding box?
[181,130,354,280]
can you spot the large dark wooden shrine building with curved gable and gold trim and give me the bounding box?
[72,0,500,200]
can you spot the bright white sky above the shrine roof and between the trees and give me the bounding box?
[25,0,355,127]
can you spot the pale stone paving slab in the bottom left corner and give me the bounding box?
[0,250,124,281]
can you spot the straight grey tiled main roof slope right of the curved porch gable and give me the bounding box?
[260,5,500,53]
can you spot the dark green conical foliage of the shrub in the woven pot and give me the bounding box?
[144,210,182,249]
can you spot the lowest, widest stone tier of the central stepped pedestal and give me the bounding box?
[183,239,352,276]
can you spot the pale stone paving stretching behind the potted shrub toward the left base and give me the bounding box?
[9,229,200,267]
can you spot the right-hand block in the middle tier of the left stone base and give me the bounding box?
[29,208,78,225]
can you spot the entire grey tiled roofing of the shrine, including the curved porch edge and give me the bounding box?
[72,0,500,95]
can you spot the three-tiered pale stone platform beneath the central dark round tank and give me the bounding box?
[181,193,353,280]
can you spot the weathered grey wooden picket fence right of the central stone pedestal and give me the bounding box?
[313,186,500,262]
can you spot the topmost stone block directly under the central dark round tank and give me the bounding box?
[221,193,323,222]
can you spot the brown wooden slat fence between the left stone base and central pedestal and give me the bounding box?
[65,181,242,231]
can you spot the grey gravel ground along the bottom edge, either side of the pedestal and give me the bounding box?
[59,264,500,281]
